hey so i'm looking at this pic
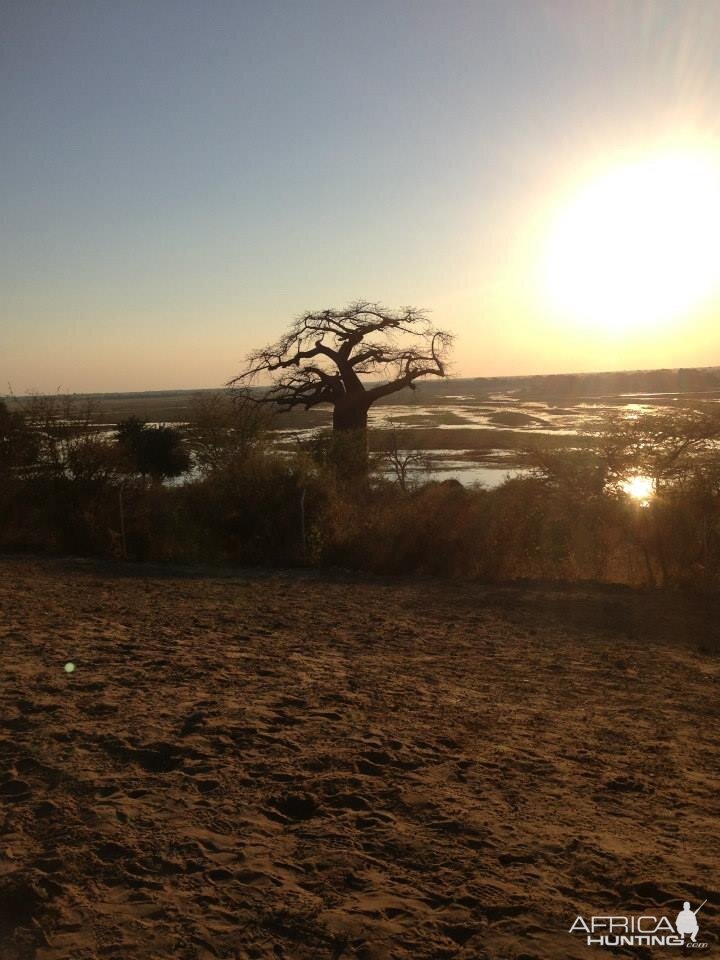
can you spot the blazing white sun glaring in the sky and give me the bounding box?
[542,151,720,333]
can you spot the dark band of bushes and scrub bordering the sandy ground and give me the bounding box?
[0,394,720,590]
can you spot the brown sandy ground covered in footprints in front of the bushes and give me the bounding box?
[0,558,720,960]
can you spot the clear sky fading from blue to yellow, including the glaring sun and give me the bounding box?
[0,0,720,393]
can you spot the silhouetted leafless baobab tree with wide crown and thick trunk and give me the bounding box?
[228,301,452,441]
